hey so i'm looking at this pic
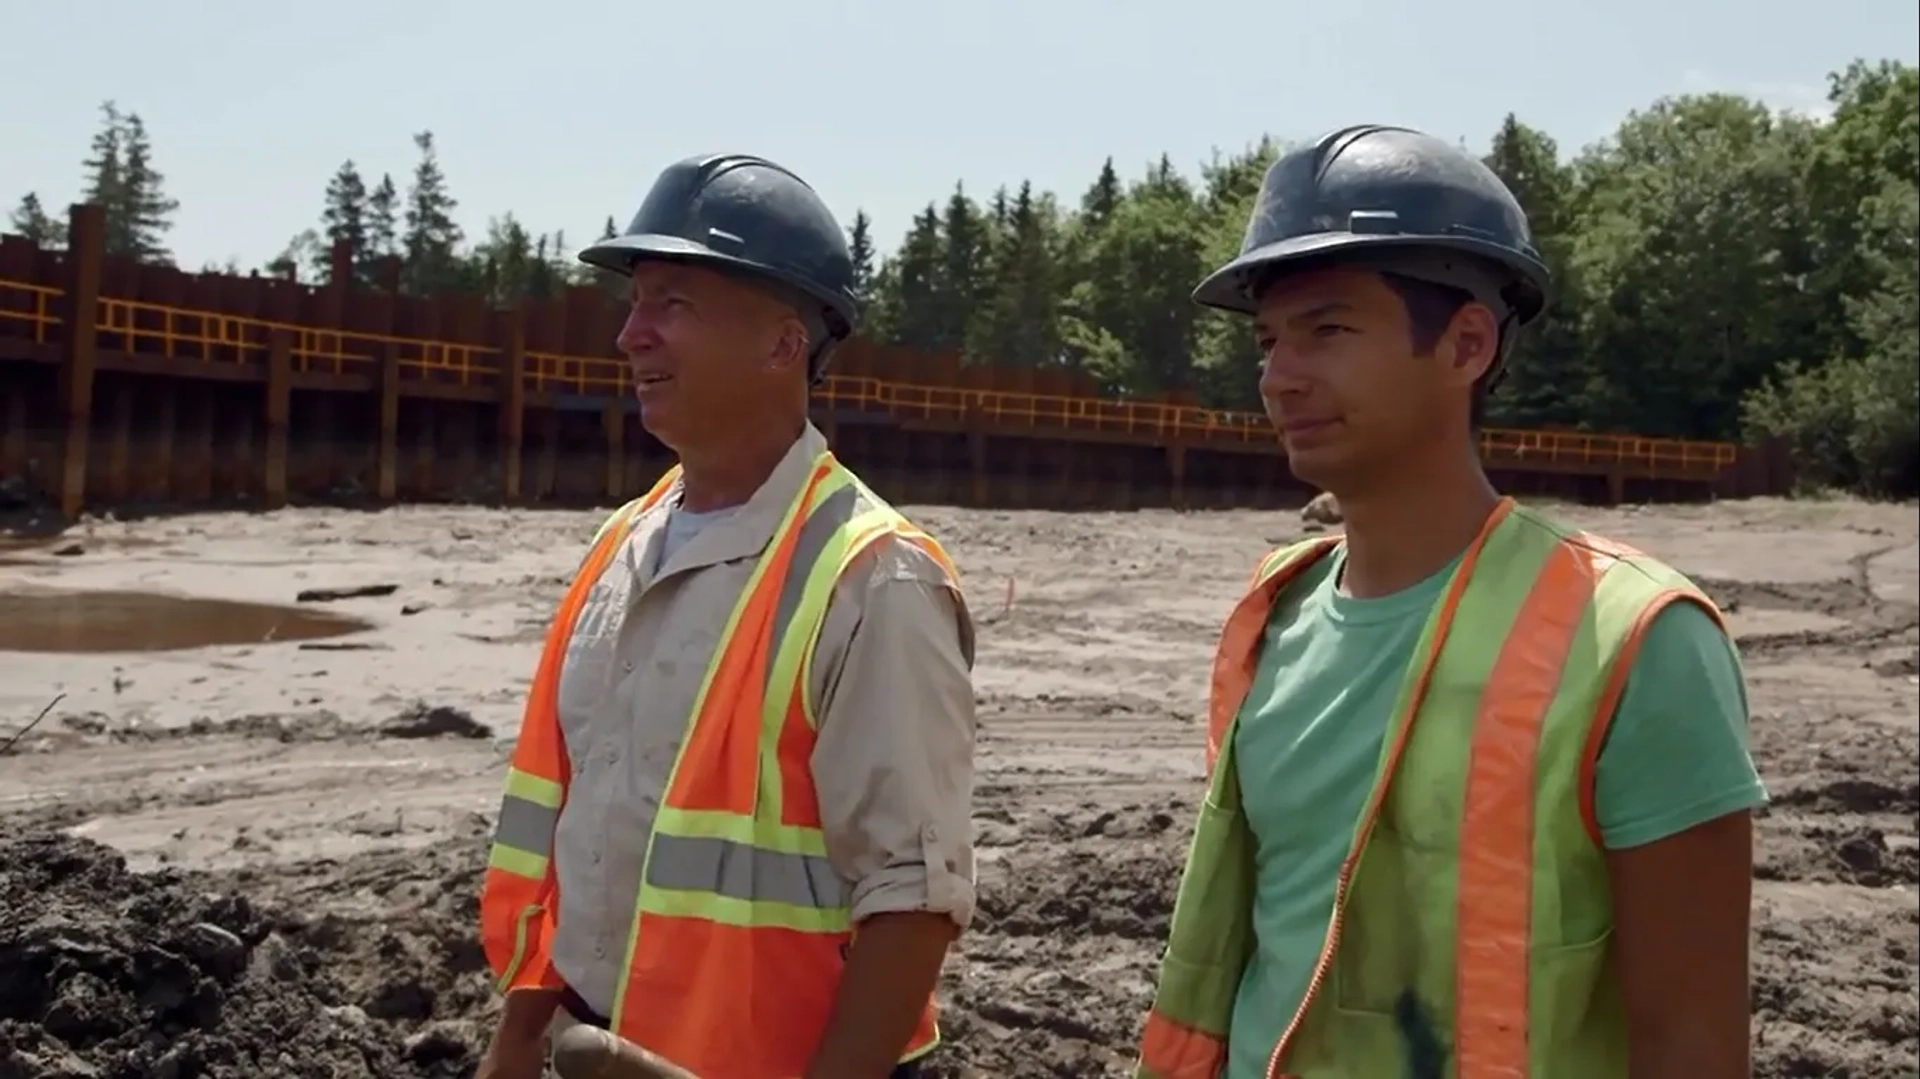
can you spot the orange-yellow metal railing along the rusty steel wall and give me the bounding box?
[0,280,1738,476]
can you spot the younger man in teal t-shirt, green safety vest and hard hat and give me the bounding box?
[1139,127,1766,1079]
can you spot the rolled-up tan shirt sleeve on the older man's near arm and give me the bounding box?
[812,545,975,929]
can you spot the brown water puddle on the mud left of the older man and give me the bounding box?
[0,591,372,653]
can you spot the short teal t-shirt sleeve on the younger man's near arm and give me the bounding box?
[1594,601,1766,851]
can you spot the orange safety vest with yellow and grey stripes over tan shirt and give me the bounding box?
[480,453,958,1079]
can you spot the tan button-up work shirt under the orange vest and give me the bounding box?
[553,424,973,1016]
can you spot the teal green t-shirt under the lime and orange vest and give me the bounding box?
[1225,547,1766,1079]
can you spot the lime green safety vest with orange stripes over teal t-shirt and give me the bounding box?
[1135,501,1720,1079]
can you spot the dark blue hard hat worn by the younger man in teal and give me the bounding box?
[1194,125,1549,324]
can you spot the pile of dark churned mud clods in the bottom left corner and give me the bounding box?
[0,833,474,1079]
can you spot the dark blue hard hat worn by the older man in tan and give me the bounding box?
[580,154,860,376]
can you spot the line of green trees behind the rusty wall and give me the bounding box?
[13,61,1920,495]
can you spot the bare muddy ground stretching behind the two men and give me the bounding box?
[0,501,1920,1079]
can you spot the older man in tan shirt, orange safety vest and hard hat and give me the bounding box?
[480,156,973,1079]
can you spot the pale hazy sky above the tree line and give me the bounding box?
[0,0,1920,269]
